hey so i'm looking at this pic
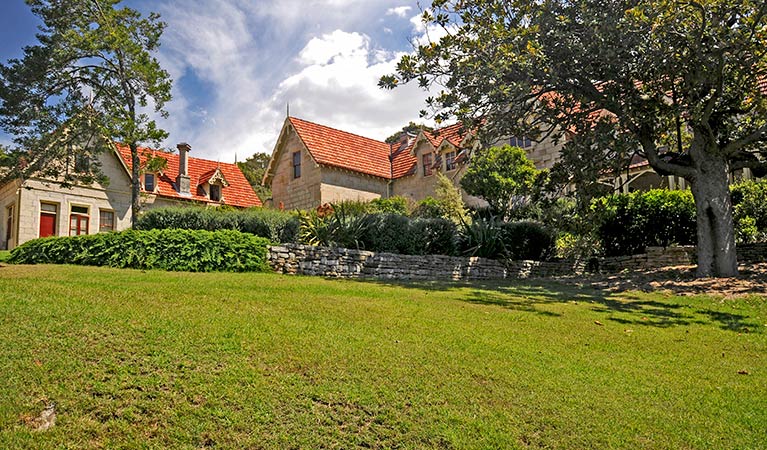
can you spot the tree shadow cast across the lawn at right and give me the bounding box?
[367,279,761,333]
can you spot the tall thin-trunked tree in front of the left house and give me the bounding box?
[0,0,171,223]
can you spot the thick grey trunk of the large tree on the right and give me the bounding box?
[691,148,738,277]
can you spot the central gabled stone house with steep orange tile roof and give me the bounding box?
[263,117,510,209]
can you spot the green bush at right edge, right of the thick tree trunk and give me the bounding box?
[730,180,767,243]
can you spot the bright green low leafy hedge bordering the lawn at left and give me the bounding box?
[10,230,269,272]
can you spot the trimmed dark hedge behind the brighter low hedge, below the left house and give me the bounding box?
[136,207,298,243]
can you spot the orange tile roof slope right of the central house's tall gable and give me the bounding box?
[290,117,391,179]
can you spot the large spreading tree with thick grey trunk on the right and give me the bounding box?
[381,0,767,276]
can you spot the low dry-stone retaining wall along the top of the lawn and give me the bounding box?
[268,244,767,280]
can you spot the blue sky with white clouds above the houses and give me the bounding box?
[0,0,444,162]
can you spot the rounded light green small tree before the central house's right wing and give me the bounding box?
[461,145,538,217]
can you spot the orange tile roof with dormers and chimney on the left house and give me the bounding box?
[115,144,262,208]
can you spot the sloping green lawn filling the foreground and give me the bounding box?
[0,266,767,449]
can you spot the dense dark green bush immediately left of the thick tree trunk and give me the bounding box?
[591,189,697,256]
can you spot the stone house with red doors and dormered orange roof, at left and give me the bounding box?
[0,144,261,249]
